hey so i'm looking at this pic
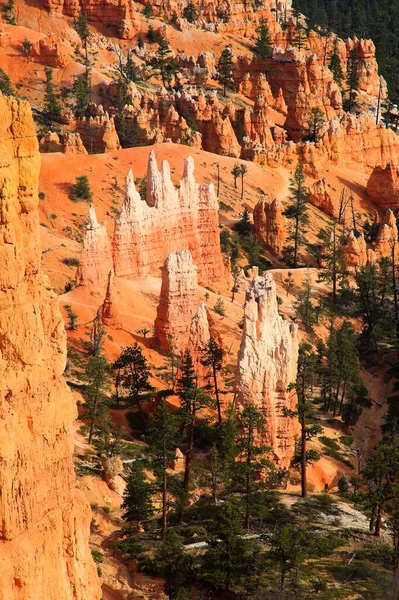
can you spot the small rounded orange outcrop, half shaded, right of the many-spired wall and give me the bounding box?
[253,198,288,256]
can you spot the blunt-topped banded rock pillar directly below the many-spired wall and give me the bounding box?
[155,250,198,351]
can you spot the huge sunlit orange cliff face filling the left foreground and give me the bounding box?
[0,95,101,600]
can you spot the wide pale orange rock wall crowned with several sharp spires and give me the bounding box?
[113,152,224,284]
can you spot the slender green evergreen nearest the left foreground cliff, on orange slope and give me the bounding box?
[81,354,109,444]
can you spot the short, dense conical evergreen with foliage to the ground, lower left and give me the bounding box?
[122,460,155,524]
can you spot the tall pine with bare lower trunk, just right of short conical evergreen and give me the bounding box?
[146,401,178,537]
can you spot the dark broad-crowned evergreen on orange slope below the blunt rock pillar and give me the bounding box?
[113,342,153,420]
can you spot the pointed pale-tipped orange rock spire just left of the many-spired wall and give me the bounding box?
[76,204,113,287]
